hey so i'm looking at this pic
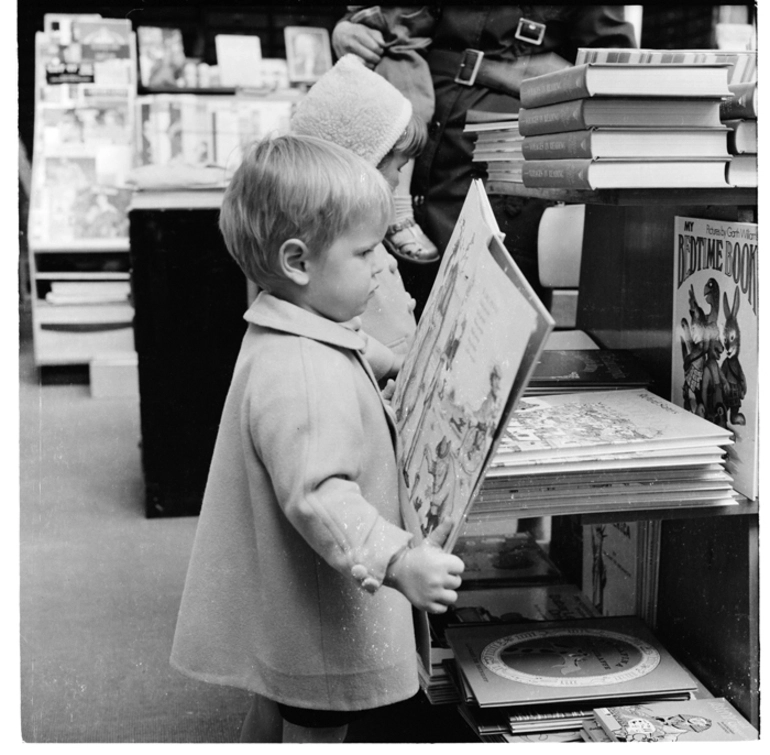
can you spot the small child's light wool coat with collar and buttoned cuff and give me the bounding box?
[171,293,418,710]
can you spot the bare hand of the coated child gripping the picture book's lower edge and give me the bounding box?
[385,521,465,613]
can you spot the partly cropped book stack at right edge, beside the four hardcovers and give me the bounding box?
[719,79,758,187]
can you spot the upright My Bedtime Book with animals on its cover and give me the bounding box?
[671,216,759,499]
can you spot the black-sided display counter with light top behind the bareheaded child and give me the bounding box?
[129,190,248,517]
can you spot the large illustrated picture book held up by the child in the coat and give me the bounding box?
[392,180,553,550]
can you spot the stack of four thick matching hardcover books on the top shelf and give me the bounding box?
[519,63,730,189]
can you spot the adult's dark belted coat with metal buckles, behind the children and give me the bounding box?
[401,5,636,307]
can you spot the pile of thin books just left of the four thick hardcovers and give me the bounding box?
[463,110,524,184]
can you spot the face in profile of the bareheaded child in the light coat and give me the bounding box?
[302,221,385,322]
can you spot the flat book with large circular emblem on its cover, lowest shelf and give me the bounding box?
[446,616,696,708]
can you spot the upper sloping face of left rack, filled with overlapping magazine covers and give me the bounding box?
[29,14,136,250]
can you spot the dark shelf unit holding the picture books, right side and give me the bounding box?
[487,184,759,726]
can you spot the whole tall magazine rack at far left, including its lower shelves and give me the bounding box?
[28,21,136,366]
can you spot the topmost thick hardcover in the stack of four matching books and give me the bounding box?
[520,63,730,108]
